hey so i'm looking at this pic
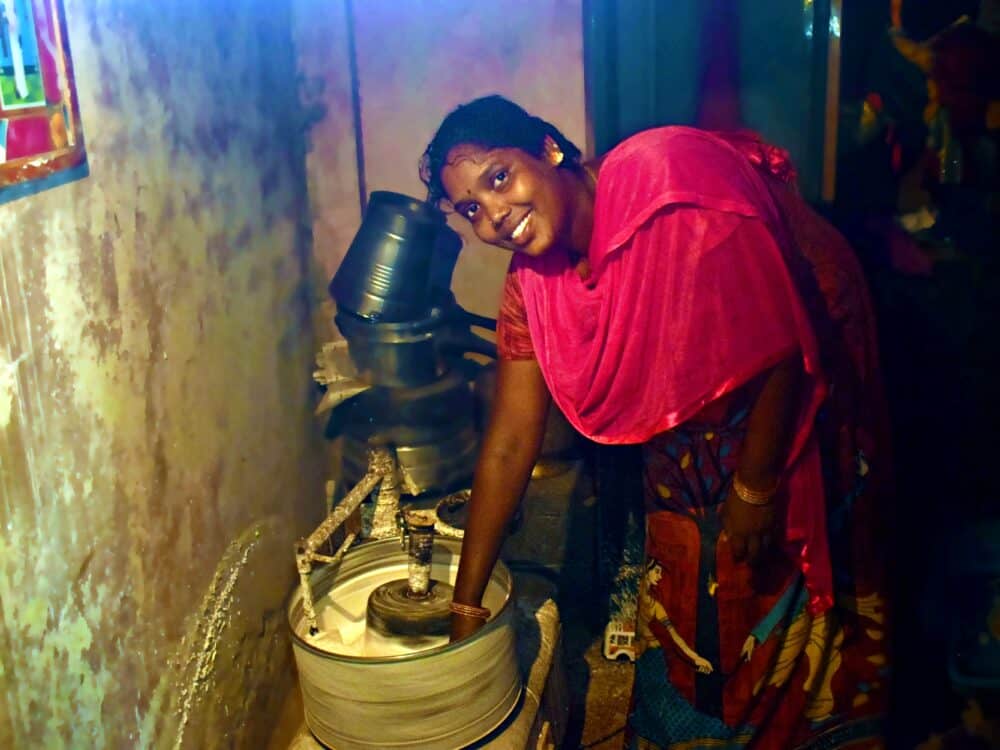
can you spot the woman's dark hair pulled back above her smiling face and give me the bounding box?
[420,94,581,209]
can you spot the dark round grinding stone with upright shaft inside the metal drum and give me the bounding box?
[366,509,454,638]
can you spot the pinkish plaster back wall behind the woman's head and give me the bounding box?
[296,0,587,326]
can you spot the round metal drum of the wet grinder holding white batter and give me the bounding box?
[288,538,522,750]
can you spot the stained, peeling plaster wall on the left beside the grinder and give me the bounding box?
[0,0,323,748]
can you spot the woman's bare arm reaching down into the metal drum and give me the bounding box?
[451,359,550,641]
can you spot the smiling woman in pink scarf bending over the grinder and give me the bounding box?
[422,96,887,749]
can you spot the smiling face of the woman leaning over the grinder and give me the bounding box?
[441,140,573,255]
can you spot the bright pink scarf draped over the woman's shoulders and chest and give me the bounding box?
[512,127,832,614]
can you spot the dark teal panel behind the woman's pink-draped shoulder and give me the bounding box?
[584,0,840,200]
